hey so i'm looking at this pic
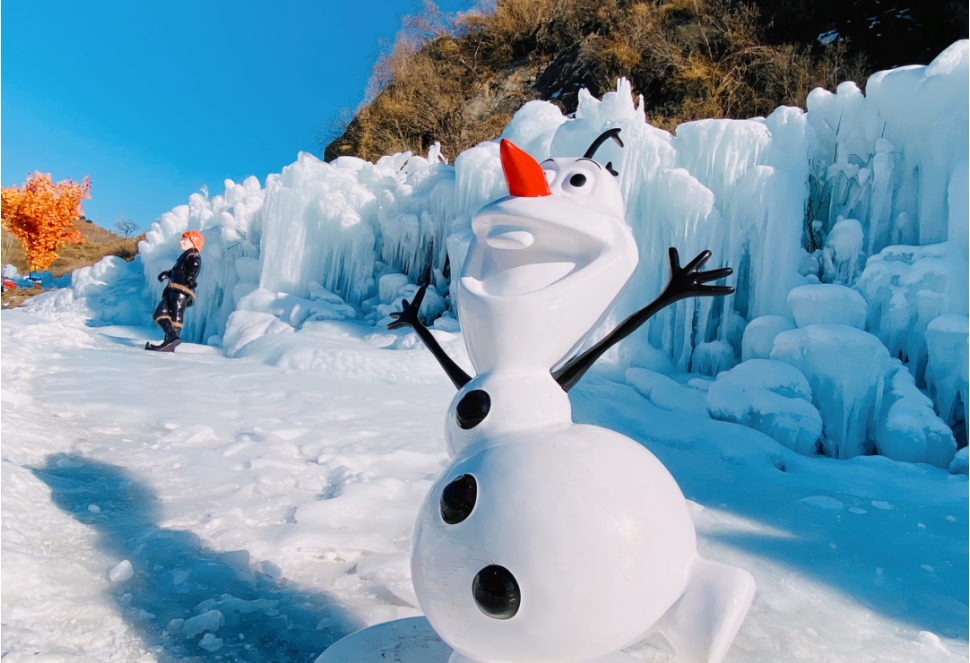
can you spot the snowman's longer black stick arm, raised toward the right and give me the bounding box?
[552,248,734,392]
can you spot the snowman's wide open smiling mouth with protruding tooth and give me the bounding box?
[462,219,603,297]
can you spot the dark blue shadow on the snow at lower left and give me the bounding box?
[31,455,364,663]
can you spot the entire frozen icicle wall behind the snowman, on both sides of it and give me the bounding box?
[58,40,970,464]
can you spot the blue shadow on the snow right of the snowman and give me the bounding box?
[570,377,968,640]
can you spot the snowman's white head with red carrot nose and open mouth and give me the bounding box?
[458,130,637,373]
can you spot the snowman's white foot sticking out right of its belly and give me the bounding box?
[647,555,755,663]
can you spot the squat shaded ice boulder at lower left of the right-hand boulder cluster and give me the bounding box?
[706,359,822,456]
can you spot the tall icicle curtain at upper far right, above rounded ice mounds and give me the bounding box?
[807,41,970,255]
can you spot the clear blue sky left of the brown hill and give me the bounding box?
[0,0,467,230]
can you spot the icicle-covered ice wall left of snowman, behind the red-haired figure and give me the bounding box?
[132,148,462,344]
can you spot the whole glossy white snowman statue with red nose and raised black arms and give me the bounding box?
[320,129,755,663]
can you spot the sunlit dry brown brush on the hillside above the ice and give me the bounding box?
[325,0,868,160]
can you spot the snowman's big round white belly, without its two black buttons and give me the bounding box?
[412,425,696,662]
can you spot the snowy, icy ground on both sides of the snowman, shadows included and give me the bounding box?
[0,311,968,663]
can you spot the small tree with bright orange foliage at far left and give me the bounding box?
[0,173,91,272]
